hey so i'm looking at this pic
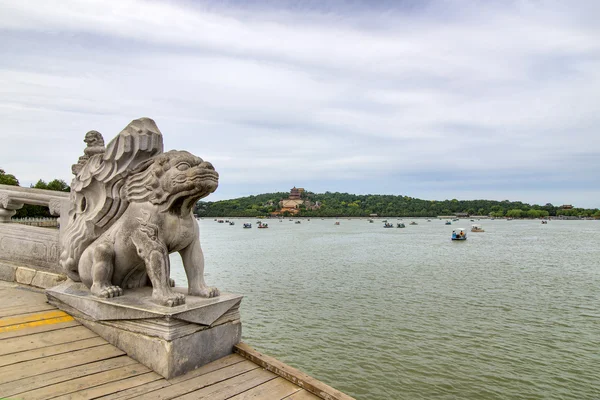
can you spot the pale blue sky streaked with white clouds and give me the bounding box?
[0,0,600,207]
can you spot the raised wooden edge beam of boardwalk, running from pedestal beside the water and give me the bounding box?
[234,342,355,400]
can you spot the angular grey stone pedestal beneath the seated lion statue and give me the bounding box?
[46,281,242,379]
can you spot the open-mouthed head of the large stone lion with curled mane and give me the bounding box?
[124,150,219,212]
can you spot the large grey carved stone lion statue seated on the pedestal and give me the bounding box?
[60,118,219,307]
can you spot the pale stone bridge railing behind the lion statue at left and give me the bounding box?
[0,185,69,281]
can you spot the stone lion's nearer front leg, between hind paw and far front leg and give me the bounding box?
[131,231,185,307]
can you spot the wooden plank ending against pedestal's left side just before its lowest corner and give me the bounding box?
[17,363,150,400]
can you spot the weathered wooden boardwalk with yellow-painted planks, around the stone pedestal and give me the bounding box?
[0,281,338,400]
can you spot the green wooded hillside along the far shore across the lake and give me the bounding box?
[194,192,600,218]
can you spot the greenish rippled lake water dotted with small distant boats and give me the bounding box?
[172,218,600,399]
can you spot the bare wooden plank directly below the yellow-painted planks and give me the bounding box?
[0,326,98,356]
